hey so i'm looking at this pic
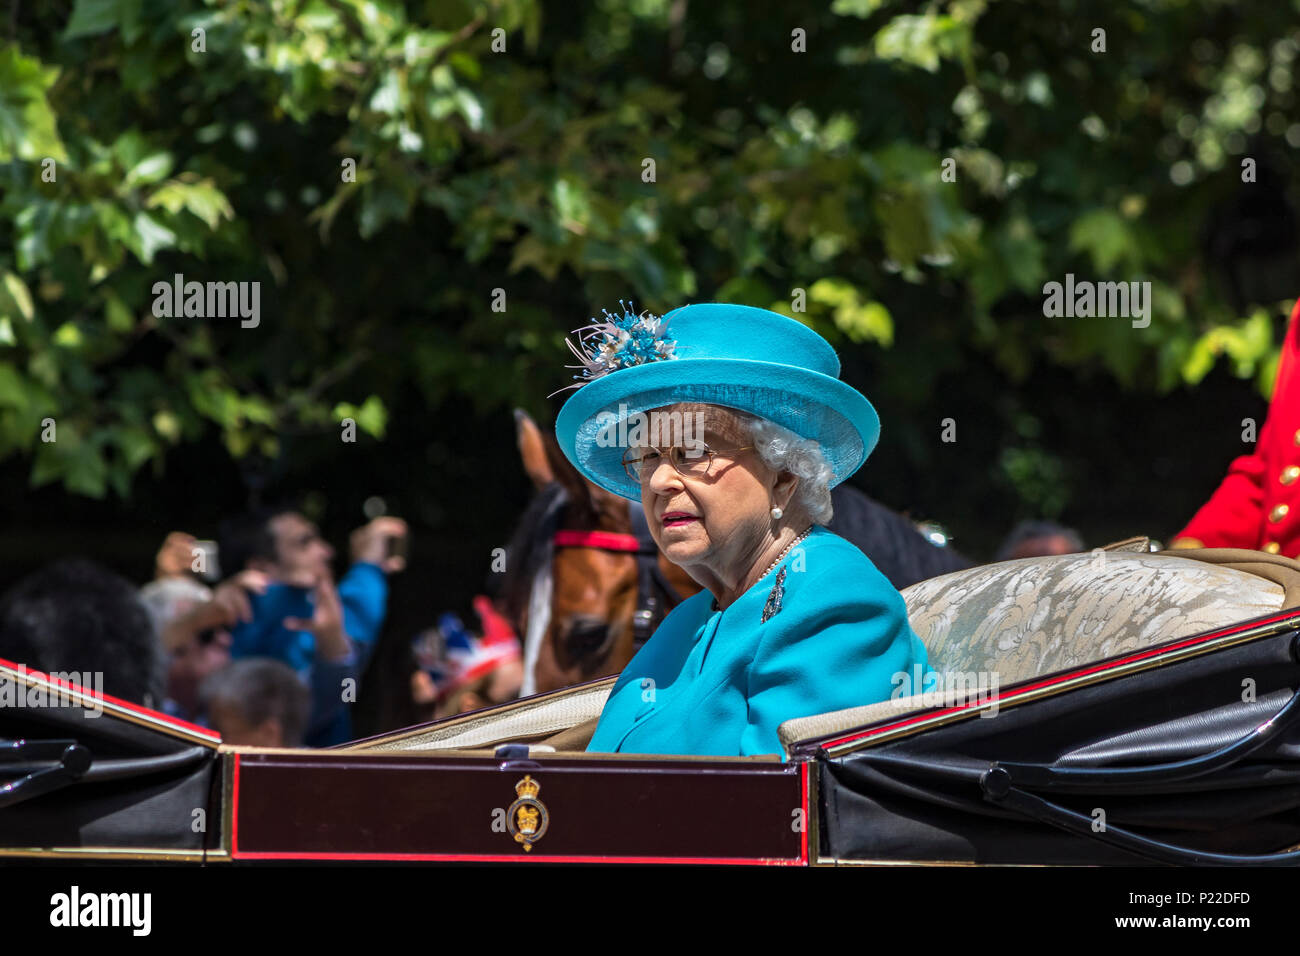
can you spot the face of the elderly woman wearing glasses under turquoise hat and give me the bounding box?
[641,406,789,584]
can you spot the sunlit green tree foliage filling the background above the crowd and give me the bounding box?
[0,0,1300,510]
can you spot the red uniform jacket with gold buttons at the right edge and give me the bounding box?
[1178,300,1300,558]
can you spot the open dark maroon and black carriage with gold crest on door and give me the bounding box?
[0,538,1300,865]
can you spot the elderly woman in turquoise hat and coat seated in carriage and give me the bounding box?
[556,304,926,754]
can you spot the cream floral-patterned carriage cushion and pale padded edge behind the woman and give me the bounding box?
[779,550,1284,749]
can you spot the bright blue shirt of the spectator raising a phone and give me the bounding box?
[230,562,389,747]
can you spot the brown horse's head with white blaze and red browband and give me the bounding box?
[506,411,699,692]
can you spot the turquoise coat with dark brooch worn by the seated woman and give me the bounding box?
[586,525,930,758]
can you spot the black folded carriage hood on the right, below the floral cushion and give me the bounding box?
[794,611,1300,866]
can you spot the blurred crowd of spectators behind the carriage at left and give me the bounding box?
[0,507,521,747]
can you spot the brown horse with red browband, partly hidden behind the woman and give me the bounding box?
[501,410,971,696]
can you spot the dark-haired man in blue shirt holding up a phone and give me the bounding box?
[221,509,407,747]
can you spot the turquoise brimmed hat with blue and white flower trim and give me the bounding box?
[555,303,880,501]
